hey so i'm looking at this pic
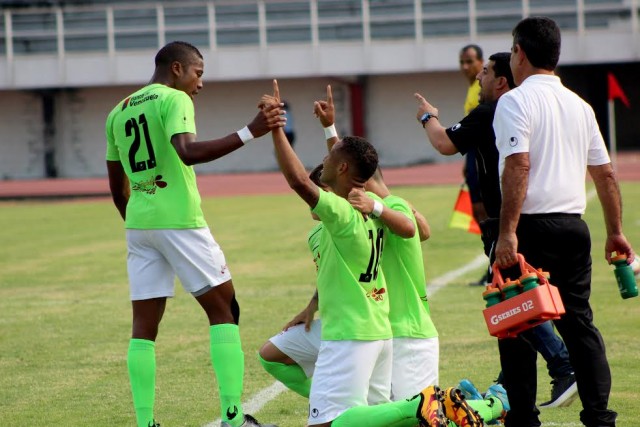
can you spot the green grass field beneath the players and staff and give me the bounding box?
[0,183,640,427]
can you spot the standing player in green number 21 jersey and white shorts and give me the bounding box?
[106,42,284,427]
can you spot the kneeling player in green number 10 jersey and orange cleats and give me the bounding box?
[263,82,510,427]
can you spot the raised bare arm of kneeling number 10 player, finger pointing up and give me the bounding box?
[261,80,320,208]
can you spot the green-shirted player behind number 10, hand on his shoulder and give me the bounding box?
[314,86,439,400]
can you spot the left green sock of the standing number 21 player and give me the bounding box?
[127,338,156,427]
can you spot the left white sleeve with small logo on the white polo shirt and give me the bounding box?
[493,91,531,159]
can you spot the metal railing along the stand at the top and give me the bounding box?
[0,0,640,60]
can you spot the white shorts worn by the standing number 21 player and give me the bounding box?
[126,227,231,301]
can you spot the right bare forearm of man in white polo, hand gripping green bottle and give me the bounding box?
[588,163,635,264]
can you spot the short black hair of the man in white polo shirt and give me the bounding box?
[511,16,561,71]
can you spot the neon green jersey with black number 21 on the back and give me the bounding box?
[105,84,207,229]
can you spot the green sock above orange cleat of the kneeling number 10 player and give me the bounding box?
[331,395,420,427]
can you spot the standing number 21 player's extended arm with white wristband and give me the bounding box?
[171,104,286,165]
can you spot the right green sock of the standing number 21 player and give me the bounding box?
[209,323,244,427]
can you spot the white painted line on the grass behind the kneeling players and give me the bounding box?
[203,255,488,427]
